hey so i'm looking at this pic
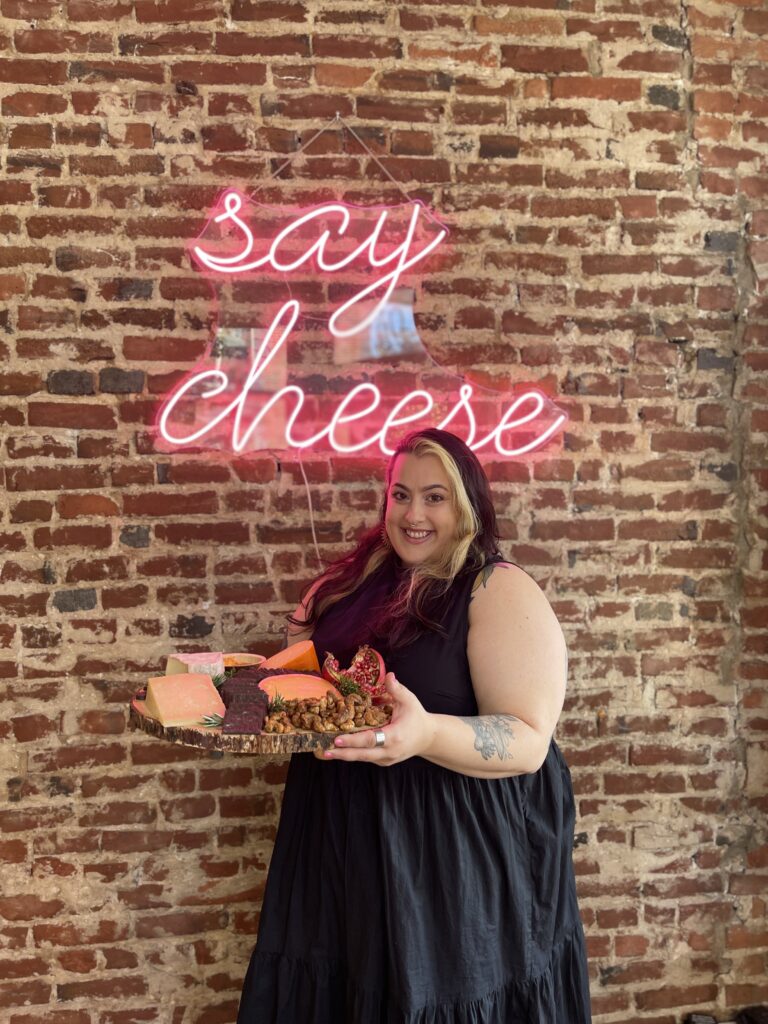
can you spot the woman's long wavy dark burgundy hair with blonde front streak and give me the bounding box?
[287,427,502,648]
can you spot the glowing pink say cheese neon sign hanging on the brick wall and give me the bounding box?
[157,189,566,456]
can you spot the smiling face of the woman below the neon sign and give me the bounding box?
[384,453,459,565]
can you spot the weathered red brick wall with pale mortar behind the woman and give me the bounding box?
[0,0,768,1024]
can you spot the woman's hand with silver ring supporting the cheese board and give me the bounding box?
[324,672,434,765]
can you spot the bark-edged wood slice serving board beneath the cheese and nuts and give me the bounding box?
[130,698,387,757]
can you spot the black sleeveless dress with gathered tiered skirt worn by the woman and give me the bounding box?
[238,559,591,1024]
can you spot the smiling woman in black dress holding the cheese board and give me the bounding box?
[238,429,591,1024]
